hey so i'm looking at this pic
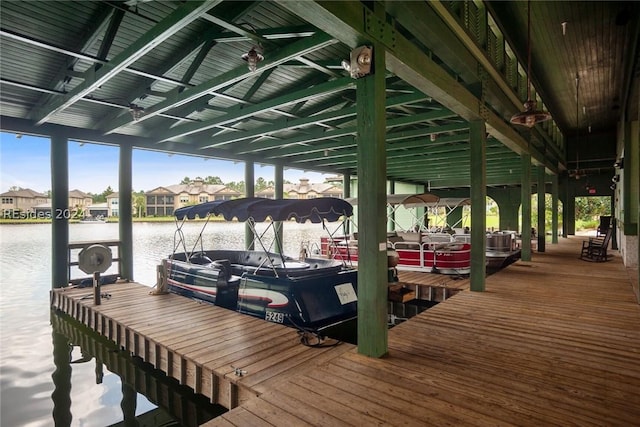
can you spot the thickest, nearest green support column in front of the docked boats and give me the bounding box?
[356,43,388,357]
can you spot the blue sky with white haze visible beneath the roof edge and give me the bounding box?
[0,132,329,194]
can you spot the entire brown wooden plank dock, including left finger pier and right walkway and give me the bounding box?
[52,238,640,427]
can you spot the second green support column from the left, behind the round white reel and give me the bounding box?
[118,144,133,280]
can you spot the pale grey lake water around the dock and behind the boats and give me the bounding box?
[0,222,326,426]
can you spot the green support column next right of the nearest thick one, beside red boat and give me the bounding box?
[469,120,487,292]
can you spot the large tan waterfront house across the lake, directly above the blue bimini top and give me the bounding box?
[145,180,242,216]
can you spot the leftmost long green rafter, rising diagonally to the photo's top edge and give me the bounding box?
[30,0,221,125]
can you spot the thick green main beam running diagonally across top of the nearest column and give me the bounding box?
[278,1,557,177]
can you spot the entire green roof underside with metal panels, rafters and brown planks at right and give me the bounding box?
[0,0,638,188]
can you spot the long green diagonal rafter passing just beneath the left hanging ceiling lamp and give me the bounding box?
[105,33,336,133]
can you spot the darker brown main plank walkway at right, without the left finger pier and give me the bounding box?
[206,238,640,427]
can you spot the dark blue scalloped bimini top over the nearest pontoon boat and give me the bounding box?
[174,197,353,223]
